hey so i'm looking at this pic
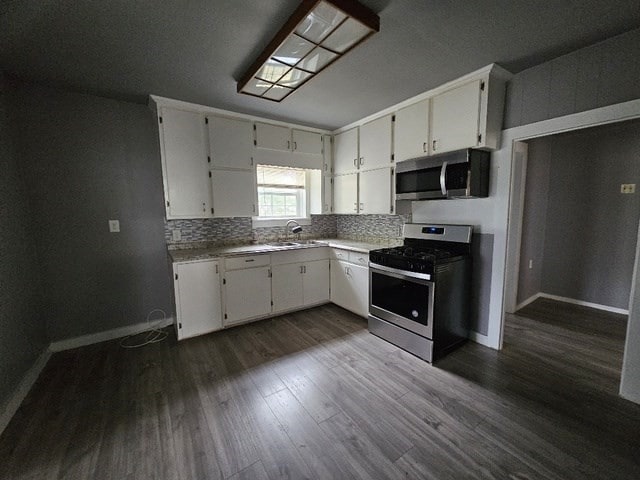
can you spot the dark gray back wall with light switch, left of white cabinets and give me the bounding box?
[12,87,171,341]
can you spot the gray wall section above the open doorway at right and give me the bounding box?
[504,29,640,128]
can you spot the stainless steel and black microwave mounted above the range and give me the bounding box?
[396,148,491,200]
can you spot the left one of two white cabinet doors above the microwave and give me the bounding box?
[393,99,429,162]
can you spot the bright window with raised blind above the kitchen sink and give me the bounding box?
[256,165,308,218]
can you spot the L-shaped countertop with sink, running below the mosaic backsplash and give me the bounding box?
[169,238,401,262]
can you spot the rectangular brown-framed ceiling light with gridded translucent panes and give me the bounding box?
[238,0,380,102]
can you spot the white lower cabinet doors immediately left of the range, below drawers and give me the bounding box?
[331,260,369,317]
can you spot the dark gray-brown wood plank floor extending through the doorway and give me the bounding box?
[0,300,640,480]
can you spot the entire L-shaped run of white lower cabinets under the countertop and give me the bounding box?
[172,241,373,340]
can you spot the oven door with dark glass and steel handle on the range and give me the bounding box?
[369,264,435,338]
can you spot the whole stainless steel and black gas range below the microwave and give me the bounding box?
[369,223,473,362]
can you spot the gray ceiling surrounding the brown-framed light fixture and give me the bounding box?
[0,0,640,129]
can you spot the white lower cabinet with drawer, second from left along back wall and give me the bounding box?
[224,255,271,325]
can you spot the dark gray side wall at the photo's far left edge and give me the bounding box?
[0,91,48,408]
